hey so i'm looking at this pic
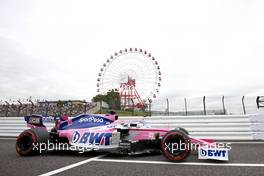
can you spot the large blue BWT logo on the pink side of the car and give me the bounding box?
[72,131,112,145]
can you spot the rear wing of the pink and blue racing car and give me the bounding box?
[24,115,59,128]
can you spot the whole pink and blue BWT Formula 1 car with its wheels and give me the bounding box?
[16,112,228,161]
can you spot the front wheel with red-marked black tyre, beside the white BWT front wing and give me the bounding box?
[161,130,191,162]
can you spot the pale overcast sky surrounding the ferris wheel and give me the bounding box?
[0,0,264,103]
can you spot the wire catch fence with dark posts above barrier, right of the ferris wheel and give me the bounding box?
[149,96,264,116]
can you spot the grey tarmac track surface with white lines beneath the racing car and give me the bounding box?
[0,138,264,176]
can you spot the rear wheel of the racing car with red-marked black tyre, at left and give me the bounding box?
[16,128,49,156]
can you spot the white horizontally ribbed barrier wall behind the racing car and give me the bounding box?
[0,114,264,140]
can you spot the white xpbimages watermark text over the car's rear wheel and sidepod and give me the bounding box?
[33,140,99,153]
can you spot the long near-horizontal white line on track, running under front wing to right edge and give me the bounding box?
[92,159,264,167]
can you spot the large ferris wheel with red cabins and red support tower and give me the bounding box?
[96,48,162,108]
